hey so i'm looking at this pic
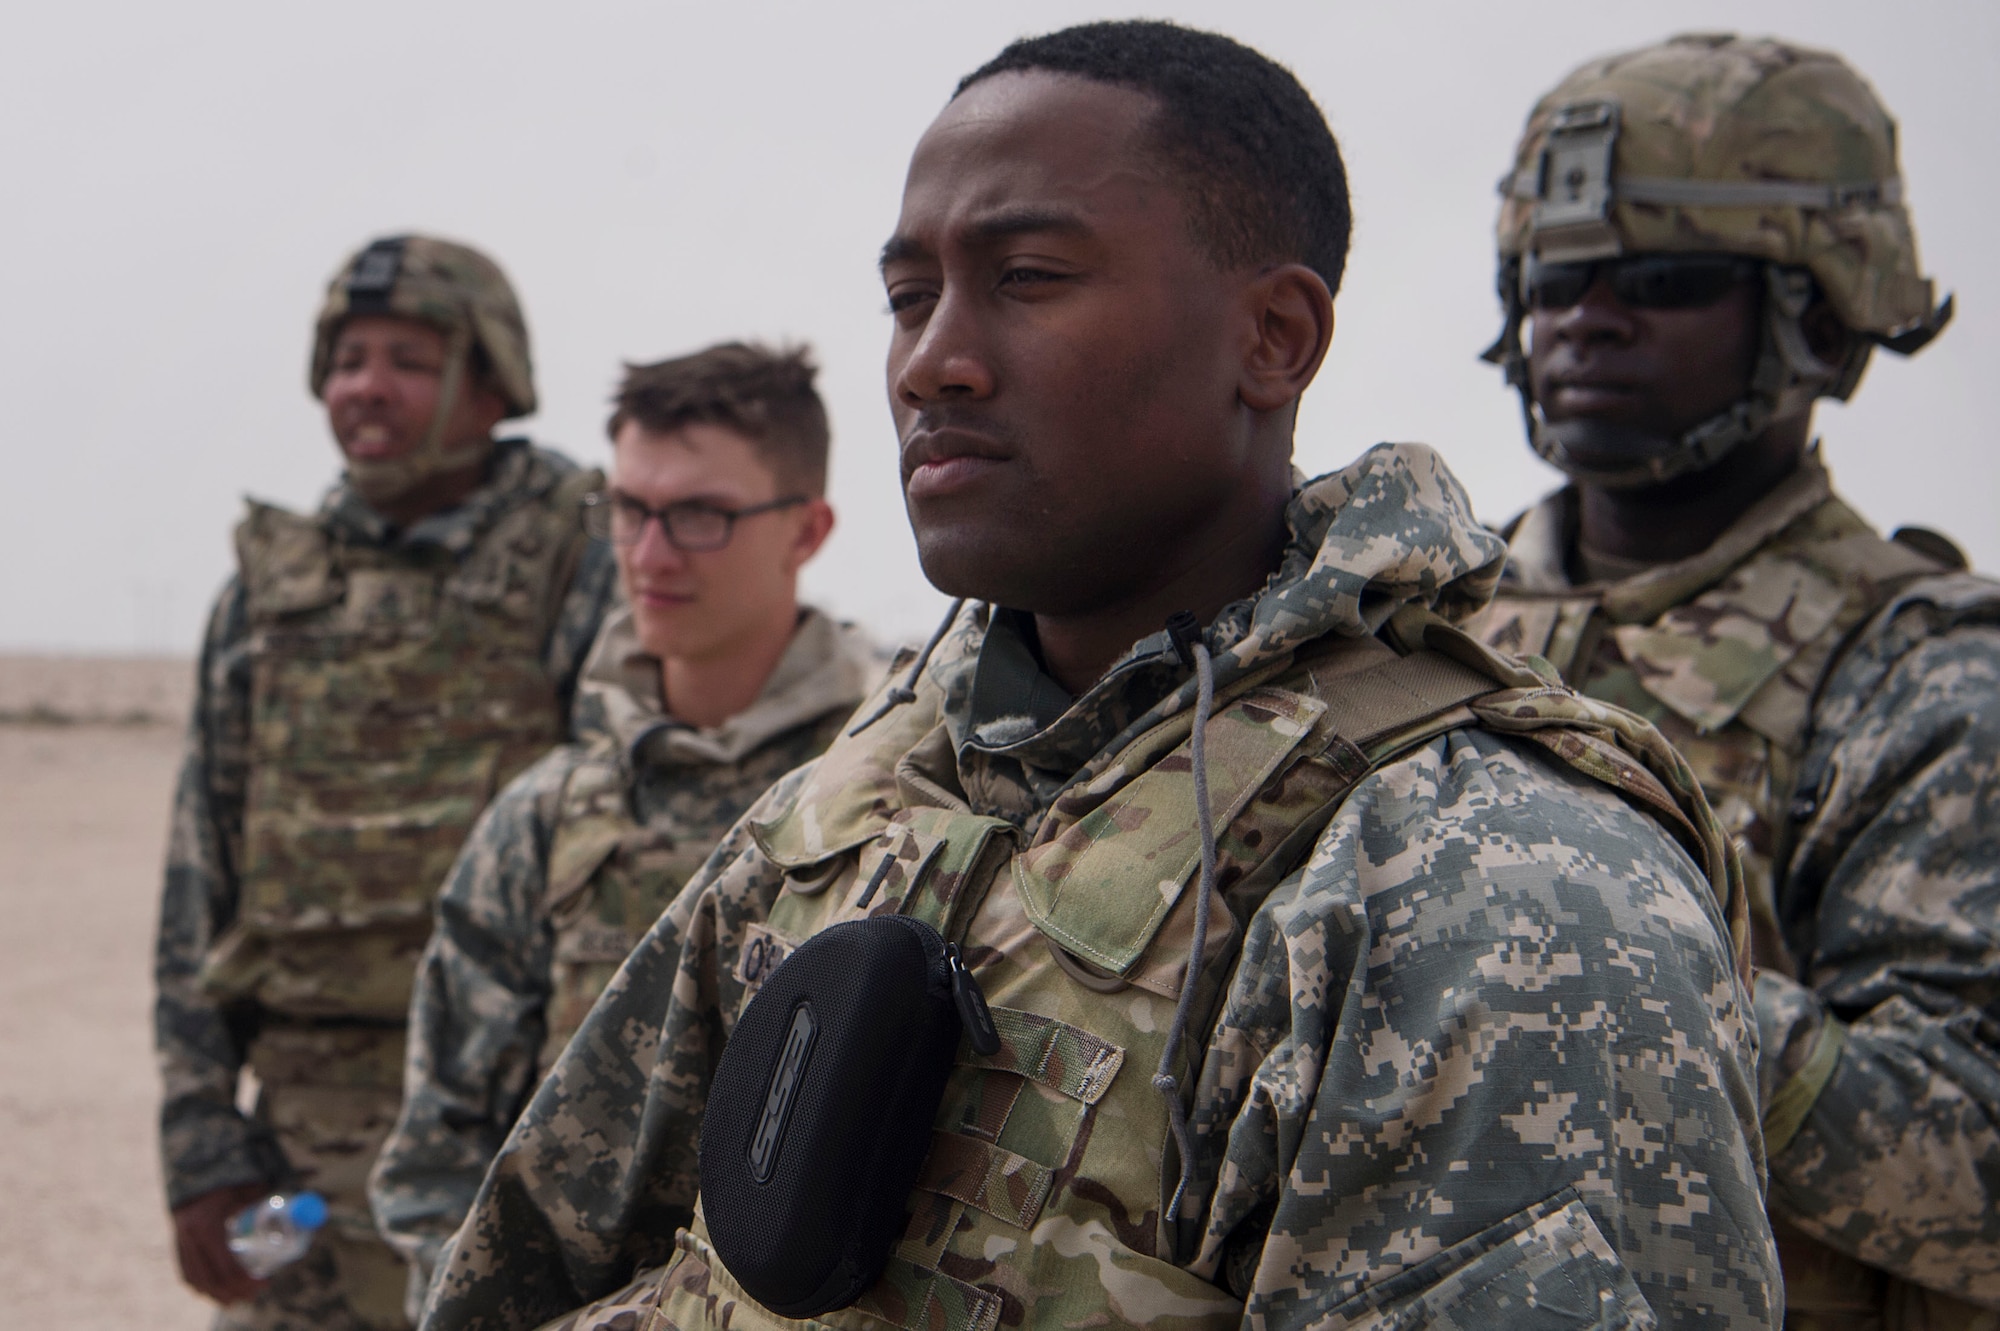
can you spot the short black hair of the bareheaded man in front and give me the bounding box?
[952,20,1354,292]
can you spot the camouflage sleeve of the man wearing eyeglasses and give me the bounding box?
[368,747,576,1289]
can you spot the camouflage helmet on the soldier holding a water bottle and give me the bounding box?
[308,236,536,494]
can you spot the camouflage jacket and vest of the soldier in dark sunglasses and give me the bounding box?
[1472,456,2000,1329]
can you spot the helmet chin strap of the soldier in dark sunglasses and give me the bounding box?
[1486,264,1870,490]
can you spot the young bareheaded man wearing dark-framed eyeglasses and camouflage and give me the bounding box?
[370,344,880,1313]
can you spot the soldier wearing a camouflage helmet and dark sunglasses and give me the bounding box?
[1474,36,2000,1329]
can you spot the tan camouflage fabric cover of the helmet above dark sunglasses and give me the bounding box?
[1498,34,1934,336]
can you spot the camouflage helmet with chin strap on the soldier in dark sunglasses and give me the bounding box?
[1486,34,1952,486]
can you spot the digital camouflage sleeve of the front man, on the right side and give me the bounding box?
[1194,731,1780,1331]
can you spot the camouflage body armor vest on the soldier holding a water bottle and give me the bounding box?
[202,463,602,1025]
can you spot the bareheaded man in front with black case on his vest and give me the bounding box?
[424,22,1778,1331]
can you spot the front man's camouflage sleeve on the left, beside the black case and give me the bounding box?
[420,767,810,1331]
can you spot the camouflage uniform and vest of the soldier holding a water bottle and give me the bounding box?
[154,440,616,1325]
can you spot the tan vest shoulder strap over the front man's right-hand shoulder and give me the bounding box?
[1016,612,1748,975]
